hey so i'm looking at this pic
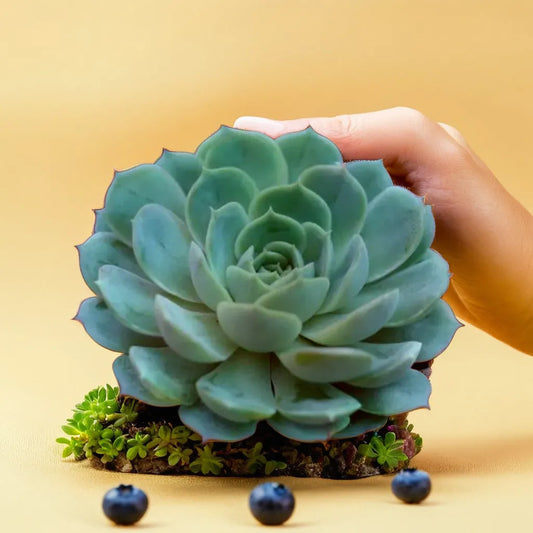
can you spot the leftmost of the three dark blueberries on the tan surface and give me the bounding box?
[102,484,148,526]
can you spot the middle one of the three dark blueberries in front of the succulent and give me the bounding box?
[249,481,294,526]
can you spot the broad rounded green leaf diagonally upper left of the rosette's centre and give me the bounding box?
[185,168,258,245]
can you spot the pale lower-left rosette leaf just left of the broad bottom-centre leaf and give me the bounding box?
[129,346,213,405]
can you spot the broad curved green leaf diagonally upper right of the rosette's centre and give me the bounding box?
[299,165,366,248]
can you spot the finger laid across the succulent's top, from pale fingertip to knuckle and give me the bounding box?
[235,107,455,173]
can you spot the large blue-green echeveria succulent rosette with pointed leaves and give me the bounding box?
[77,127,459,441]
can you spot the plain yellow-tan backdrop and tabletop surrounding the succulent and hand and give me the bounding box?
[0,0,533,532]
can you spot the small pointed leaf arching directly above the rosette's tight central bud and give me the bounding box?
[235,209,305,257]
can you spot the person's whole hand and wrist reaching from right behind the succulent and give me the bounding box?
[235,107,533,355]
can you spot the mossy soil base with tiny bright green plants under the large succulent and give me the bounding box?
[57,385,422,478]
